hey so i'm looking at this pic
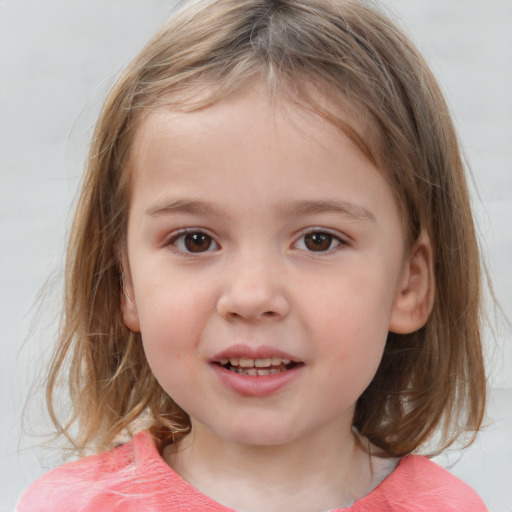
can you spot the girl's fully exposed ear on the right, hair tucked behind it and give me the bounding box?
[389,233,435,334]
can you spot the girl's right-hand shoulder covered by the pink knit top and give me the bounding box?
[354,455,487,512]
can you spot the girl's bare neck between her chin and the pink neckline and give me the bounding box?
[164,423,375,512]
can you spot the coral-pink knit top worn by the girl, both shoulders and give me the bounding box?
[16,432,487,512]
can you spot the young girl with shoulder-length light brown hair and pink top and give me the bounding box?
[17,0,486,512]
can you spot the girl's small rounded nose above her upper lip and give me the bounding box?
[217,257,290,321]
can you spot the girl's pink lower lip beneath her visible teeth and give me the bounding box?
[212,364,304,397]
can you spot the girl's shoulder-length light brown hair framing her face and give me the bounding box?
[47,0,485,456]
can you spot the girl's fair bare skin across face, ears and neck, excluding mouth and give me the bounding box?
[124,84,432,512]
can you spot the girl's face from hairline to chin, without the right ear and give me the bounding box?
[124,83,412,445]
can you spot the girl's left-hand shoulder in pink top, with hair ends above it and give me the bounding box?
[16,432,229,512]
